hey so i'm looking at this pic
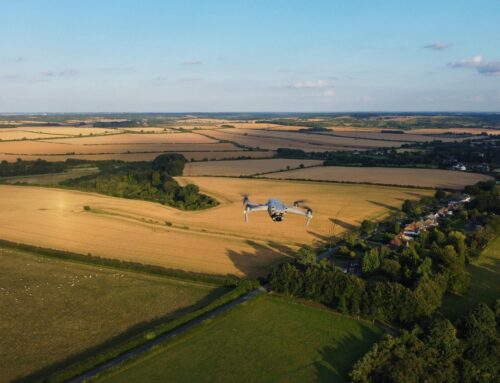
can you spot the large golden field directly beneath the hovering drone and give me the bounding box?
[0,177,432,276]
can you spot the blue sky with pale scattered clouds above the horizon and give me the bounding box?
[0,0,500,113]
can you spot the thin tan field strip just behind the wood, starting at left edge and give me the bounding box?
[0,150,275,162]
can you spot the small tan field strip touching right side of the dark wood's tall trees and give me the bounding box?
[184,158,323,177]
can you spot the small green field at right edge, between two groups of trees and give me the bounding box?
[442,236,500,320]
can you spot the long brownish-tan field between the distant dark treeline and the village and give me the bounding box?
[263,166,491,189]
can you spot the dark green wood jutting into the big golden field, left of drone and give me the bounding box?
[61,153,217,210]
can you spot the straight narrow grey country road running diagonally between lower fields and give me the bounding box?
[69,286,267,383]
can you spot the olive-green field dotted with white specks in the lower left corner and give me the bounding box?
[0,247,225,382]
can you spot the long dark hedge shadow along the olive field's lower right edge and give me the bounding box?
[12,287,228,383]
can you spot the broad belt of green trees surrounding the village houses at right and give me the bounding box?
[269,181,500,324]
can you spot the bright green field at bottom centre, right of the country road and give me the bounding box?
[101,296,381,383]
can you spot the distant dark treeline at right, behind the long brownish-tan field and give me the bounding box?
[276,138,500,172]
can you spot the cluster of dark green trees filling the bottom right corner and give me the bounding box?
[350,301,500,383]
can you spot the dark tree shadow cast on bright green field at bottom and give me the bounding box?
[314,324,381,383]
